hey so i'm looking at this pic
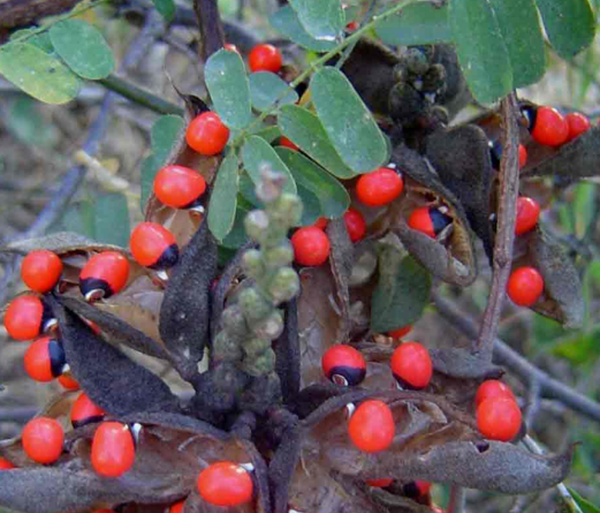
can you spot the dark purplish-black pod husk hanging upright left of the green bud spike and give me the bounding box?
[158,220,217,376]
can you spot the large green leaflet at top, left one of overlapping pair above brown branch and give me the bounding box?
[448,0,513,103]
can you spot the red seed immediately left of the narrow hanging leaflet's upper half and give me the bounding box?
[154,165,206,208]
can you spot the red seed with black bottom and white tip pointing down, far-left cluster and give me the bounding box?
[79,251,130,300]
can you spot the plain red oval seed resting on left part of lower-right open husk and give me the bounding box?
[348,399,396,453]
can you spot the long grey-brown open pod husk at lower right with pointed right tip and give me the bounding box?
[306,401,573,494]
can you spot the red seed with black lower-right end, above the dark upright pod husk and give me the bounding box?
[129,223,179,268]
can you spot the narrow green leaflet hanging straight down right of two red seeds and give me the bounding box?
[208,151,238,240]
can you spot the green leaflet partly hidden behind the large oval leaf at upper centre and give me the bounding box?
[277,105,357,179]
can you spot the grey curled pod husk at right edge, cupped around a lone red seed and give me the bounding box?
[513,225,585,328]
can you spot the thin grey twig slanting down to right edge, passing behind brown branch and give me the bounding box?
[433,292,600,422]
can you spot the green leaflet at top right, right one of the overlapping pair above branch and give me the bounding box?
[493,0,546,88]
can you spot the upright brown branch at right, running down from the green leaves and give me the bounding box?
[474,93,519,364]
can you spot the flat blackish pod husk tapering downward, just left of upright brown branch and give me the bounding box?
[425,125,494,261]
